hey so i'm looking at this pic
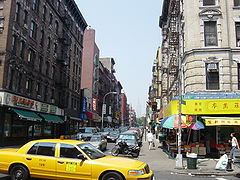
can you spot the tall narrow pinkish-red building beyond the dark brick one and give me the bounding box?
[81,28,101,126]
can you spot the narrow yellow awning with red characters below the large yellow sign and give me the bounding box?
[202,117,240,126]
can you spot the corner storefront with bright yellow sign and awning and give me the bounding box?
[164,93,240,158]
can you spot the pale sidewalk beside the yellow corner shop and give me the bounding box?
[139,136,240,176]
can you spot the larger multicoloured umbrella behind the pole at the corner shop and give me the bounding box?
[161,115,187,129]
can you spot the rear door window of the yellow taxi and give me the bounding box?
[27,142,56,156]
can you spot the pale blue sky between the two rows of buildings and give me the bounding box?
[75,0,162,117]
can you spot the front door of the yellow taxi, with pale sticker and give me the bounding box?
[56,143,92,180]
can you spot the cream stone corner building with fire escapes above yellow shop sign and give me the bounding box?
[159,0,240,156]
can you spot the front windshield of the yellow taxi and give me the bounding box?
[78,143,106,159]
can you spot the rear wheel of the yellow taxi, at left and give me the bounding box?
[10,165,29,180]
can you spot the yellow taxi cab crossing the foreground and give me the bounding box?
[0,139,154,180]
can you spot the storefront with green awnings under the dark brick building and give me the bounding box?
[0,92,64,146]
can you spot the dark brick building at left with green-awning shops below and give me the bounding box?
[0,0,87,145]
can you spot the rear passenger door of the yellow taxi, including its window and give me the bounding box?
[23,142,56,179]
